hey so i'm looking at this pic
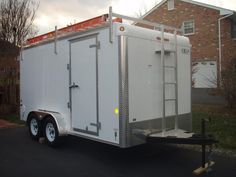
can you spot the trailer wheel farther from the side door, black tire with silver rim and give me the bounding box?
[27,113,42,141]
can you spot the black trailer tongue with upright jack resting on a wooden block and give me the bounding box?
[147,119,218,175]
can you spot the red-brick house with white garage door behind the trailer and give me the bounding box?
[141,0,236,88]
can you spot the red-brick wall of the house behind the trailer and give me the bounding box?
[144,0,236,64]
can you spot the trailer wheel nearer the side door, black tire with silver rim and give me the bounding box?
[44,117,61,147]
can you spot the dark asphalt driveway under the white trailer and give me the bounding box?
[0,127,236,177]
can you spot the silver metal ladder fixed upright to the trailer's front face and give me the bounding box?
[161,26,178,136]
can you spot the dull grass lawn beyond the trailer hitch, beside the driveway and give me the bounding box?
[193,105,236,150]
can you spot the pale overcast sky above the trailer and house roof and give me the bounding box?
[35,0,236,34]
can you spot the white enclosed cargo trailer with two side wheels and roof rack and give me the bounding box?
[20,11,192,147]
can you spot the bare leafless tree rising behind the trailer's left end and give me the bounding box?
[0,0,39,46]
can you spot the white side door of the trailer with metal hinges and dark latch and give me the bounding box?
[70,35,99,135]
